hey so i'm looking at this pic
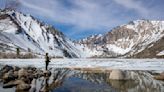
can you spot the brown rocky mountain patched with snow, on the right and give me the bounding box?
[77,20,164,58]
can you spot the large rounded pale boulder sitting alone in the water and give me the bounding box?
[109,70,126,80]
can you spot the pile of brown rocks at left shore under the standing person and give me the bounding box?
[0,65,51,92]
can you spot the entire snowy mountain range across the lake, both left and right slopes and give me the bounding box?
[0,10,164,58]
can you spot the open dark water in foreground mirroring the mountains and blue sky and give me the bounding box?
[0,68,164,92]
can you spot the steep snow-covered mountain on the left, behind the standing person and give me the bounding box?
[0,10,80,57]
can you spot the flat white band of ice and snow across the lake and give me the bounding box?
[0,59,164,71]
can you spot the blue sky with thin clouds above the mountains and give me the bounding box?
[0,0,164,39]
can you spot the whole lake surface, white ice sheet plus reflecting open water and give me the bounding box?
[0,59,164,92]
